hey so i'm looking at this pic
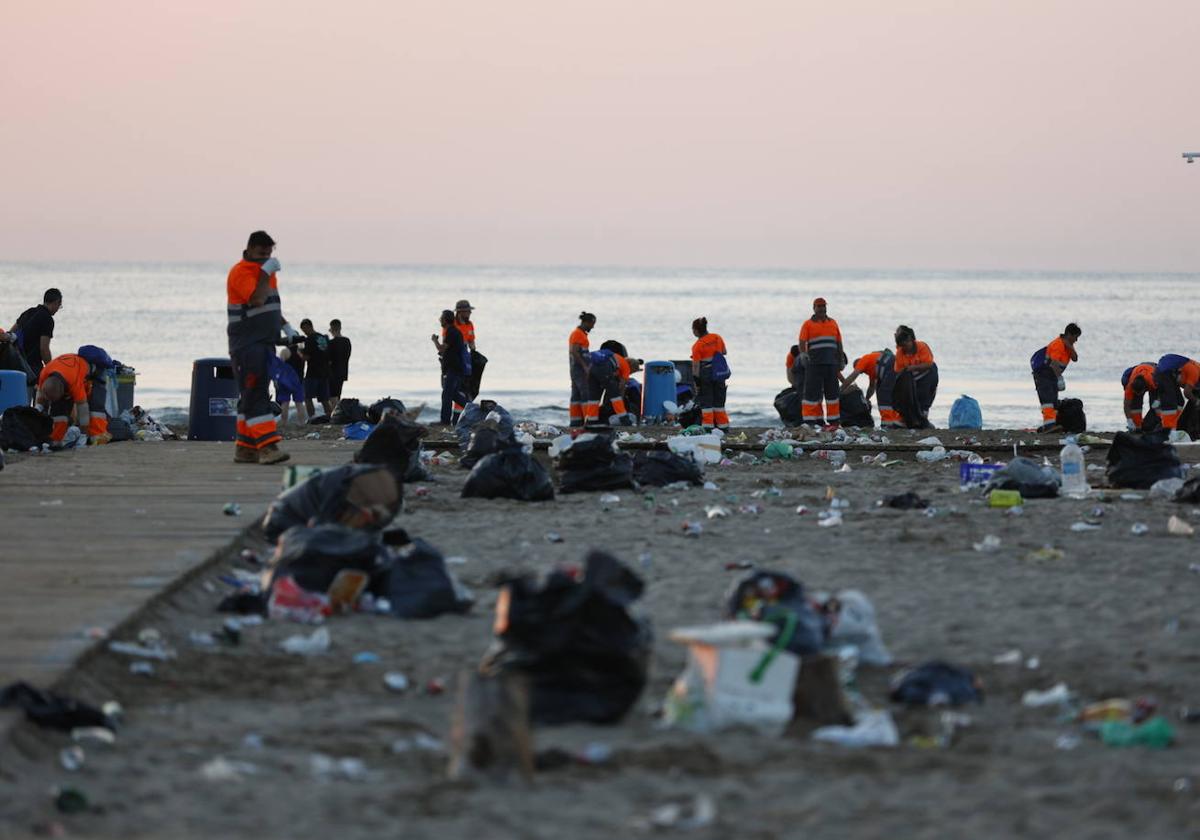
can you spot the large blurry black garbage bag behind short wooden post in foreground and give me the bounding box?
[480,551,653,725]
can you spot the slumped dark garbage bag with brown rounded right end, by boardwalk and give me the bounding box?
[263,463,403,542]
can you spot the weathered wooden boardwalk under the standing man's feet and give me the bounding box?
[0,440,359,686]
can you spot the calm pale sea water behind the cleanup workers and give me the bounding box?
[0,262,1200,428]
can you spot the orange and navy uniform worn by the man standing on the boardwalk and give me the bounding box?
[226,259,283,449]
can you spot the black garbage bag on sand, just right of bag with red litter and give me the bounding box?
[370,538,475,618]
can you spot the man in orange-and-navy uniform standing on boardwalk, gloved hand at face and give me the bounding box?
[226,230,298,464]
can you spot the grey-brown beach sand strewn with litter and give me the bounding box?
[0,432,1200,839]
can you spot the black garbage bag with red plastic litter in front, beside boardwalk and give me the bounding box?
[266,524,390,595]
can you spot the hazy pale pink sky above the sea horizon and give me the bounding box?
[0,0,1200,271]
